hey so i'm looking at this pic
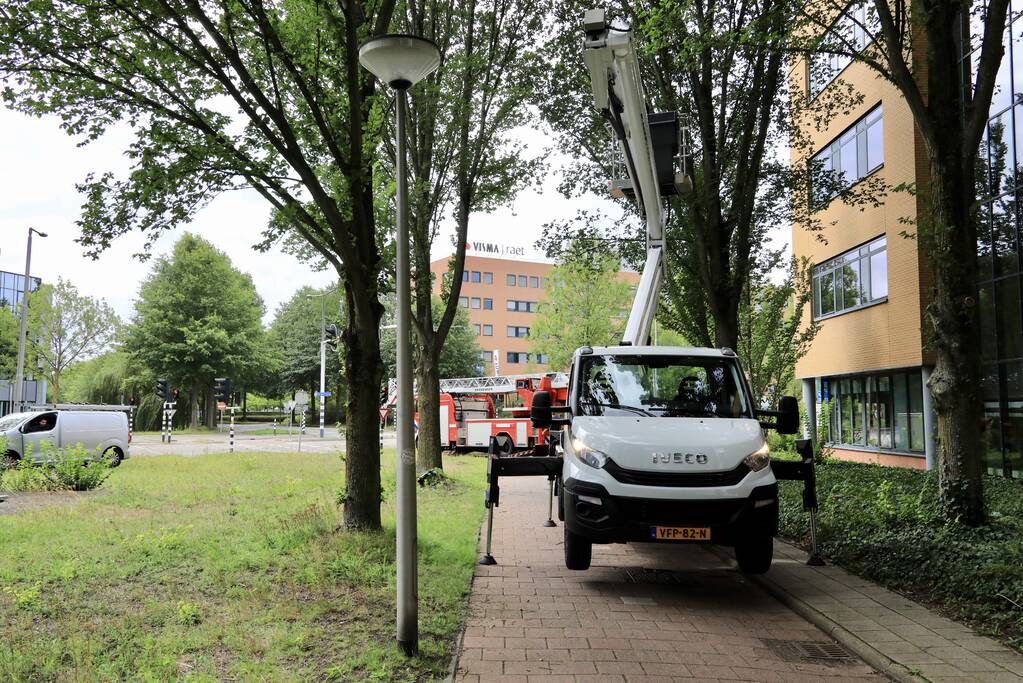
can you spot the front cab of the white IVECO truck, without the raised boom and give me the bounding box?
[532,346,798,573]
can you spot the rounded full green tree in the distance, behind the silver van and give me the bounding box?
[125,233,272,426]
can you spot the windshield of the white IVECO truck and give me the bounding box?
[577,355,750,417]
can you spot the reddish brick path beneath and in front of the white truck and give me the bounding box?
[455,477,884,683]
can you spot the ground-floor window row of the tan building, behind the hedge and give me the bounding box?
[820,368,924,453]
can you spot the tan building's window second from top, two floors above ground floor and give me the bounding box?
[810,105,885,209]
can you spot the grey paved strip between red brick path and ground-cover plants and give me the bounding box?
[755,542,1023,683]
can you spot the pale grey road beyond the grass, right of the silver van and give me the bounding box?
[131,424,395,457]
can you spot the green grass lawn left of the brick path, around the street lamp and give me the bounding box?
[0,451,486,681]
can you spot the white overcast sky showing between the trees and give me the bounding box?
[0,106,618,322]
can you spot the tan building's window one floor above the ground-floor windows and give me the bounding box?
[813,237,888,319]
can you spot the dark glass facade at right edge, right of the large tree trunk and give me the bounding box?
[961,5,1023,477]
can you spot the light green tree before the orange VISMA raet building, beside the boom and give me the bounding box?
[529,240,631,370]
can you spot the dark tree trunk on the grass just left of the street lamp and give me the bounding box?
[343,285,384,530]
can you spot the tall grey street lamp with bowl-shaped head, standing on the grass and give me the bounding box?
[359,35,441,655]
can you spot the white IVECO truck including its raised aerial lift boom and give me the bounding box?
[531,10,799,574]
